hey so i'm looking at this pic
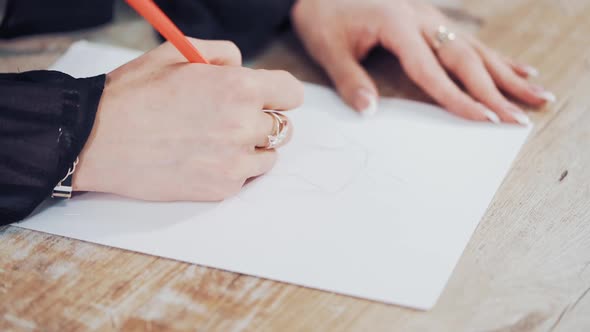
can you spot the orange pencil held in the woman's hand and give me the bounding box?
[126,0,209,63]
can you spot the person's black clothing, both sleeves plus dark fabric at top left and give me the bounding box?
[0,0,294,226]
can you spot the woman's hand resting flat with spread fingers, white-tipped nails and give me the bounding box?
[291,0,555,124]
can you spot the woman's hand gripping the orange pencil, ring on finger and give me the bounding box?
[74,39,303,201]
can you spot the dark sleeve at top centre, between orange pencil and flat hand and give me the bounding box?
[156,0,295,57]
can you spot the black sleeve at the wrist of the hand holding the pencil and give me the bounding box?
[0,71,105,226]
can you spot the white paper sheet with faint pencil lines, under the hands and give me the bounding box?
[18,43,530,309]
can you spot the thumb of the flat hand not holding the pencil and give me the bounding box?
[324,51,379,115]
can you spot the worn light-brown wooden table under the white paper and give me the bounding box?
[0,0,590,331]
